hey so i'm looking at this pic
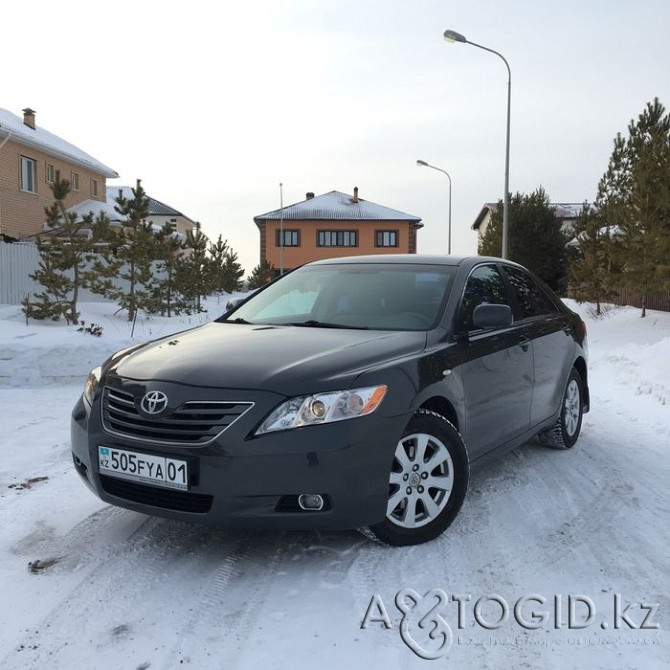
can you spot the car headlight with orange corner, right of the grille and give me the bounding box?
[256,385,386,435]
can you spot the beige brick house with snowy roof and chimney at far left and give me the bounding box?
[0,108,119,240]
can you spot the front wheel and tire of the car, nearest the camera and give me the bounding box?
[362,410,470,546]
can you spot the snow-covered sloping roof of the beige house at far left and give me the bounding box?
[0,109,119,179]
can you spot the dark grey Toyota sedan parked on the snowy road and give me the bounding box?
[72,255,589,545]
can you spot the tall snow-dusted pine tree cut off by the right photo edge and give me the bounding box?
[596,98,670,317]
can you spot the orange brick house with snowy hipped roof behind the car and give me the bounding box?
[254,187,423,270]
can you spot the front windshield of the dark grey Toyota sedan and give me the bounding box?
[223,263,456,330]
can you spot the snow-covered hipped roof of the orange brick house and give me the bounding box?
[254,191,421,224]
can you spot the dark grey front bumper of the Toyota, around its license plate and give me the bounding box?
[71,397,410,530]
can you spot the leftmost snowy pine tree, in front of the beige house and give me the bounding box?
[22,170,110,323]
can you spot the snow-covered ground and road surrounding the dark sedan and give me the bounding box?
[0,301,670,670]
